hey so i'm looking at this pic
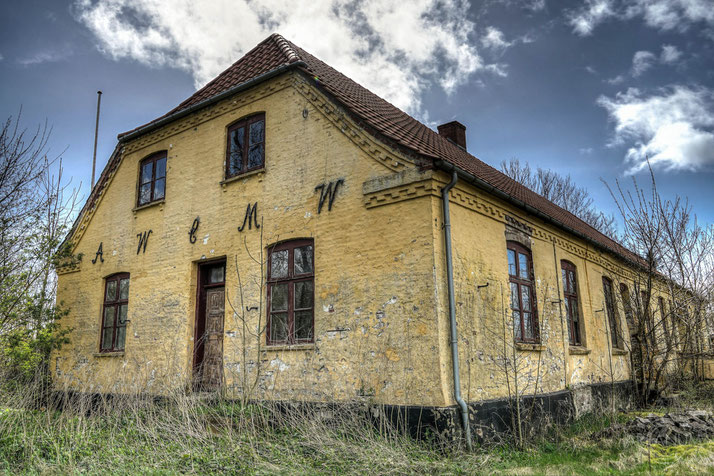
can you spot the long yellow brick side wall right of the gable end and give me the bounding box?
[422,173,684,410]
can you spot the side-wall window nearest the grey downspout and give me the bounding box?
[507,241,540,342]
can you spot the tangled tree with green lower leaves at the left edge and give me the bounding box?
[0,110,77,390]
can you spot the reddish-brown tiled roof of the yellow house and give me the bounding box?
[114,33,642,263]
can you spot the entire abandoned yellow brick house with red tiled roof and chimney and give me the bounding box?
[52,34,700,438]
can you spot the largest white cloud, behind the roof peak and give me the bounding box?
[74,0,498,113]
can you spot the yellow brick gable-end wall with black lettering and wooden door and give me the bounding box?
[53,74,445,405]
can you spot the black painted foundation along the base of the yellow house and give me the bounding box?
[48,381,632,444]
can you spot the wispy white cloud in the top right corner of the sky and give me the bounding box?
[567,0,714,36]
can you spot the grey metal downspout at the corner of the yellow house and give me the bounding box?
[441,171,473,451]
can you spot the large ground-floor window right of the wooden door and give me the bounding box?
[267,240,315,345]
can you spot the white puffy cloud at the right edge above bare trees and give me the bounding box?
[597,86,714,173]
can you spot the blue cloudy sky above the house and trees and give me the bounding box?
[0,0,714,227]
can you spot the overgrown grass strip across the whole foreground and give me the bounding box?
[0,384,714,475]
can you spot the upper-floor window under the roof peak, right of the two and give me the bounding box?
[226,113,265,179]
